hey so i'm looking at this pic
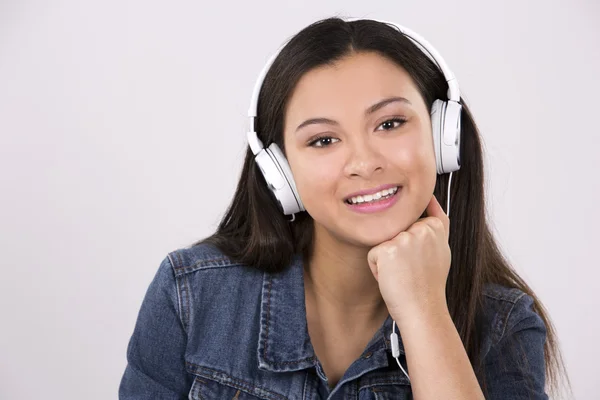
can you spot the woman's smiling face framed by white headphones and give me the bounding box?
[284,52,436,247]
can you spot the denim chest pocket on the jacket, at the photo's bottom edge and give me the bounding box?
[188,376,285,400]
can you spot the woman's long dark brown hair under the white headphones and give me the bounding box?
[195,18,570,400]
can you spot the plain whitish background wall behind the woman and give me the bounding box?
[0,0,600,400]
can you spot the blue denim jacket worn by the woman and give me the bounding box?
[119,244,548,400]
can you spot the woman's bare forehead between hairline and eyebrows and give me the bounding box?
[286,52,421,119]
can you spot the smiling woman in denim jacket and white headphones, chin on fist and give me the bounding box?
[119,18,568,400]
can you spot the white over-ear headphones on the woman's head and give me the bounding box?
[247,18,462,221]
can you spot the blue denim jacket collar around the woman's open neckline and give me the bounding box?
[257,255,404,372]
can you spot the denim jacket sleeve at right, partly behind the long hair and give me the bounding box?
[485,294,548,400]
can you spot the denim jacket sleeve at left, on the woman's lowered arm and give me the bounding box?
[119,256,192,400]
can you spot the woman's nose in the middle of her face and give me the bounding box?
[344,137,385,179]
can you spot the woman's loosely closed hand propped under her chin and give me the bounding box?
[368,196,451,322]
